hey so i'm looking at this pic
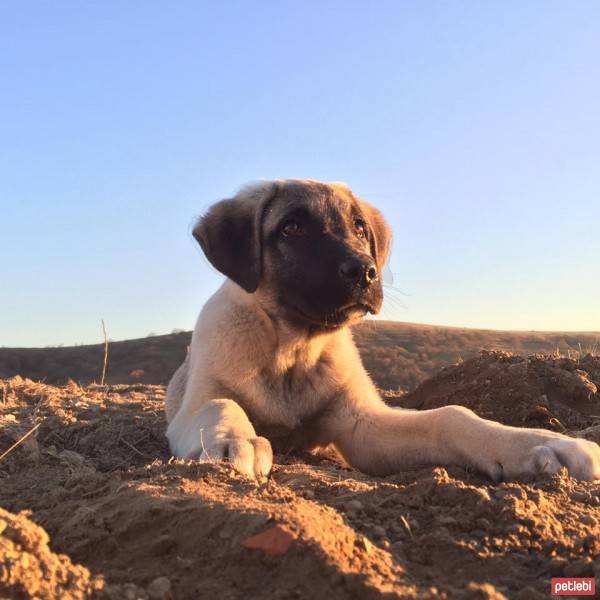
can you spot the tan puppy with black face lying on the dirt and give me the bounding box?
[166,180,600,481]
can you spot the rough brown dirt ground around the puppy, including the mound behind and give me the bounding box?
[0,352,600,600]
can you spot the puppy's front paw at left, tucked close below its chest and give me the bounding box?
[200,436,273,480]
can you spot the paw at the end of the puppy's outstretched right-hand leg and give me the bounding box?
[485,430,600,481]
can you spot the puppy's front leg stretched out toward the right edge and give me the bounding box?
[328,398,600,481]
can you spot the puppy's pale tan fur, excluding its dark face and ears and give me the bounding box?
[166,181,600,480]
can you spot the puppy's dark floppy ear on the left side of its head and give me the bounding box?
[193,182,276,293]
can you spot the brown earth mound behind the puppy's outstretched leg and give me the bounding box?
[392,352,600,441]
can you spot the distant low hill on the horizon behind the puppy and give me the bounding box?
[0,321,600,391]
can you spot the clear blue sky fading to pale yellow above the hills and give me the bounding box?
[0,0,600,346]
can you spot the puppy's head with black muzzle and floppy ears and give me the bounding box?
[194,180,390,329]
